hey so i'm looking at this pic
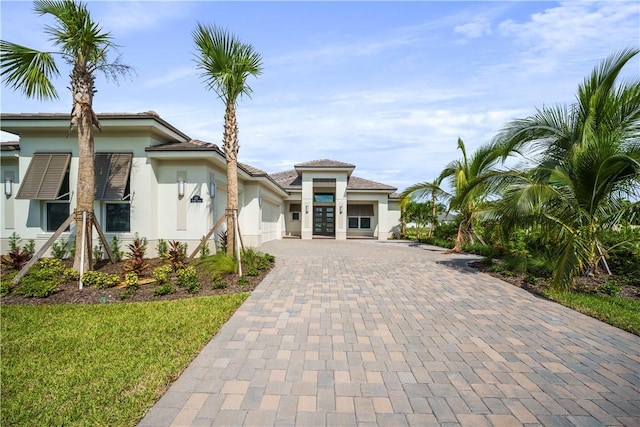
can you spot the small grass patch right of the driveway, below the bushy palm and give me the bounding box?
[543,289,640,335]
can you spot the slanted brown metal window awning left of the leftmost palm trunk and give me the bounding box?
[16,153,71,200]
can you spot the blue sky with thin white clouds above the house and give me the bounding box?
[0,0,640,191]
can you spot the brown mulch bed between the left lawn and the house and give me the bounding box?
[0,258,273,305]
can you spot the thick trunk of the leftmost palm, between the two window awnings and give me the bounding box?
[71,66,98,271]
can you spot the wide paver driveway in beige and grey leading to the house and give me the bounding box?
[140,240,640,426]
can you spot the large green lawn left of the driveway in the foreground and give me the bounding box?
[0,294,248,426]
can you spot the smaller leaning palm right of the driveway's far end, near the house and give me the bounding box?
[403,138,502,252]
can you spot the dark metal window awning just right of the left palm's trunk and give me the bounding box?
[94,153,133,200]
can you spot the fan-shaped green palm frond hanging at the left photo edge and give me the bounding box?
[0,40,60,99]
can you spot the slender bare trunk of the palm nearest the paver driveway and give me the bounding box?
[223,102,240,256]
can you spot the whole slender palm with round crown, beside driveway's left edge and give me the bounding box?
[193,24,262,256]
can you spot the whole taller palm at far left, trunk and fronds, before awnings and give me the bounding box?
[0,0,130,271]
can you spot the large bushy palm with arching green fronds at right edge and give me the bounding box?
[494,49,640,288]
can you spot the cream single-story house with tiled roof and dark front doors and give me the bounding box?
[0,111,400,252]
